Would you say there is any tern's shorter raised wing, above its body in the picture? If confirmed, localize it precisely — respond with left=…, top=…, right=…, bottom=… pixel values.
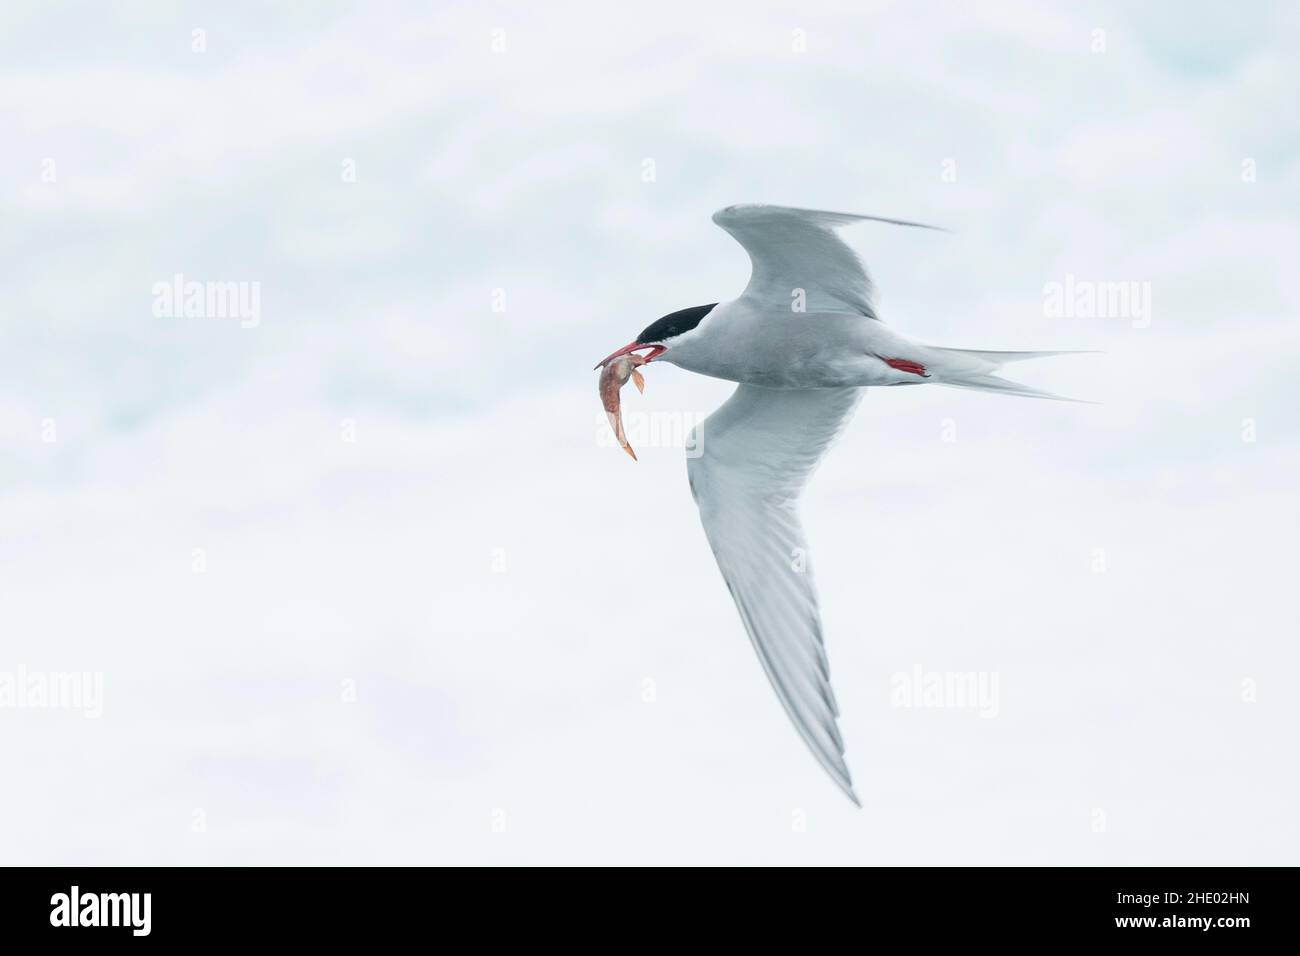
left=714, top=204, right=939, bottom=319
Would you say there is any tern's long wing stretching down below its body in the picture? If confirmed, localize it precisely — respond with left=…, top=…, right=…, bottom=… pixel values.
left=686, top=385, right=862, bottom=806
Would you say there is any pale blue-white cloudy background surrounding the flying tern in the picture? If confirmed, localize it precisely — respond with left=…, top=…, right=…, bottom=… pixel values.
left=0, top=3, right=1300, bottom=864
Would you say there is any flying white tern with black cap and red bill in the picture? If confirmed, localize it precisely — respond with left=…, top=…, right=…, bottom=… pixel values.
left=597, top=204, right=1067, bottom=806
